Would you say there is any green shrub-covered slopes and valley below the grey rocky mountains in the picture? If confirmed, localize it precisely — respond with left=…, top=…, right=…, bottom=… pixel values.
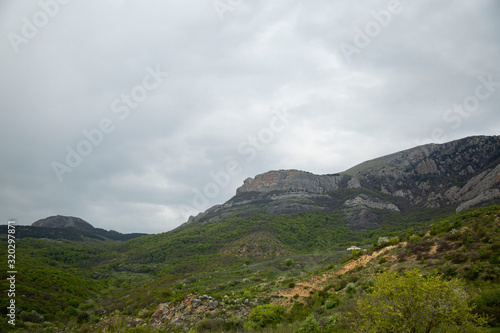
left=0, top=206, right=500, bottom=332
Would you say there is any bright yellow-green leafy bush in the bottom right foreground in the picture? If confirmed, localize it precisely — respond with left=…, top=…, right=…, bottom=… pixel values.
left=346, top=269, right=486, bottom=333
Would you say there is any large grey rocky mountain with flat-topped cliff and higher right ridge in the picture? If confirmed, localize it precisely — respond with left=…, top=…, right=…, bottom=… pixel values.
left=188, top=136, right=500, bottom=230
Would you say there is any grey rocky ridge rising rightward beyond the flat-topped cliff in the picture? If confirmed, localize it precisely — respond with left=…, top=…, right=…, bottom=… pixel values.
left=344, top=136, right=500, bottom=208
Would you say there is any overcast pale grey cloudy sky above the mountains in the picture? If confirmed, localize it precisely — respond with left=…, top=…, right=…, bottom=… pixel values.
left=0, top=0, right=500, bottom=233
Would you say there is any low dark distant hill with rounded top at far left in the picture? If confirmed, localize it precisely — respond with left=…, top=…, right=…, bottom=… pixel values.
left=0, top=215, right=146, bottom=241
